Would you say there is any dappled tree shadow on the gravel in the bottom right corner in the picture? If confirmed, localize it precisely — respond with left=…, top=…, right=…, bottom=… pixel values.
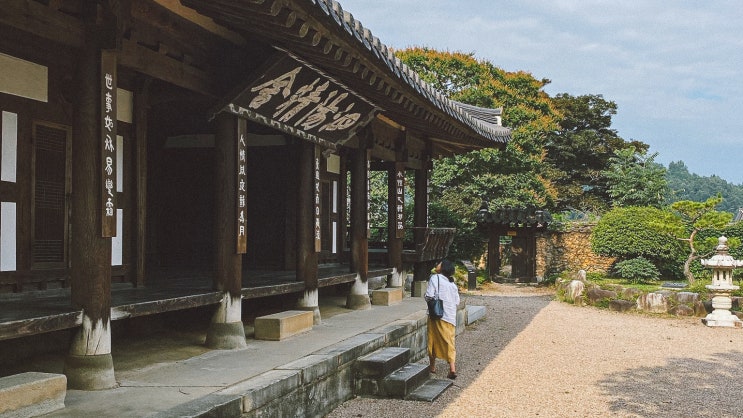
left=599, top=352, right=743, bottom=417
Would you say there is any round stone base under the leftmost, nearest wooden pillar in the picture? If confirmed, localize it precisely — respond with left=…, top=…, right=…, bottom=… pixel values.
left=64, top=353, right=118, bottom=390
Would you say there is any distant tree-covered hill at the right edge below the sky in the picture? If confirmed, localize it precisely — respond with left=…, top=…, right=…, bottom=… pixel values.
left=666, top=161, right=743, bottom=214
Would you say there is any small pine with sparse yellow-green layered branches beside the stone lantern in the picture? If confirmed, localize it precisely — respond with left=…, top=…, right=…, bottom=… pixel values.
left=659, top=196, right=732, bottom=284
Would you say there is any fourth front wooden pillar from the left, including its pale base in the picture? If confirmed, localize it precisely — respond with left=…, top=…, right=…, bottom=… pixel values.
left=346, top=137, right=371, bottom=309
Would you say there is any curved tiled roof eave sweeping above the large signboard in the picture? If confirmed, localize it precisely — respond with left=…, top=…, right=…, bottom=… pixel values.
left=182, top=0, right=511, bottom=151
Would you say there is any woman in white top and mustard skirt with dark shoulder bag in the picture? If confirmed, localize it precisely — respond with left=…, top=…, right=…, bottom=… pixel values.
left=425, top=259, right=459, bottom=379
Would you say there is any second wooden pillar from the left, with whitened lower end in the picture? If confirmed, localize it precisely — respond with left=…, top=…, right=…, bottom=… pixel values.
left=206, top=113, right=247, bottom=349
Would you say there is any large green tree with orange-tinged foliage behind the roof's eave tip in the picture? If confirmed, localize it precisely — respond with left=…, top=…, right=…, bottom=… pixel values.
left=396, top=48, right=558, bottom=258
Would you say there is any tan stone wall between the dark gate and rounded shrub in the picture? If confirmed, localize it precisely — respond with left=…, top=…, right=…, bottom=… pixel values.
left=536, top=223, right=615, bottom=278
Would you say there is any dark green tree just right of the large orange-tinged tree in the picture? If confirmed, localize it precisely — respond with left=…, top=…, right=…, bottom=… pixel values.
left=545, top=93, right=648, bottom=213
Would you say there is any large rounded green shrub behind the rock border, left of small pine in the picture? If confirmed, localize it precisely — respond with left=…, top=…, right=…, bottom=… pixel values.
left=591, top=206, right=684, bottom=278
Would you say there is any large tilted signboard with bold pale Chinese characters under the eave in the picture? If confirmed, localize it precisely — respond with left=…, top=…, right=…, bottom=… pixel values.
left=218, top=55, right=376, bottom=148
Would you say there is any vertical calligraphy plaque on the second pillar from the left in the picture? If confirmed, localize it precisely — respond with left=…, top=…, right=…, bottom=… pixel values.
left=235, top=118, right=248, bottom=254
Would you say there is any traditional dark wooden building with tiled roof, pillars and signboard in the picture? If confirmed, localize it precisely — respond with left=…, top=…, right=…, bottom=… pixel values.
left=0, top=0, right=510, bottom=389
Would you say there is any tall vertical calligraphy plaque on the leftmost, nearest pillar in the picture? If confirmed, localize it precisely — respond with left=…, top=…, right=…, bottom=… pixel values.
left=99, top=50, right=117, bottom=237
